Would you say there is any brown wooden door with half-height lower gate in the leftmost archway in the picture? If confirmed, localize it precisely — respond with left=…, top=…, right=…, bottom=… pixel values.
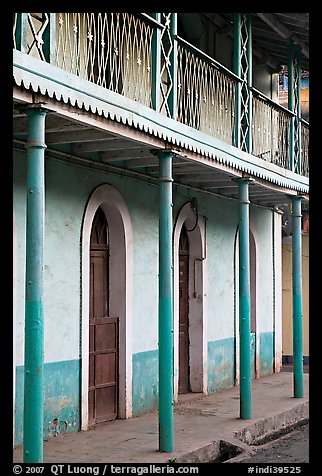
left=88, top=208, right=118, bottom=425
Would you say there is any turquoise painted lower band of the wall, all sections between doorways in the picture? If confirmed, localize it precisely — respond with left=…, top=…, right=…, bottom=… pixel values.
left=15, top=332, right=274, bottom=446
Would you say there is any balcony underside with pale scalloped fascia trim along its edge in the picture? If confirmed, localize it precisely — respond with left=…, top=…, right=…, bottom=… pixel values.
left=13, top=51, right=309, bottom=206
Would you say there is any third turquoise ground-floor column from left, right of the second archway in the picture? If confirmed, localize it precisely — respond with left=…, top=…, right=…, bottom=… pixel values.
left=237, top=179, right=252, bottom=420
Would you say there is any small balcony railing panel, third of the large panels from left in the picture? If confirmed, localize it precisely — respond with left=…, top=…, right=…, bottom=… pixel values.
left=252, top=88, right=292, bottom=169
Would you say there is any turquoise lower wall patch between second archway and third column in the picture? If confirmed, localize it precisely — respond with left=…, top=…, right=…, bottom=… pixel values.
left=208, top=337, right=235, bottom=393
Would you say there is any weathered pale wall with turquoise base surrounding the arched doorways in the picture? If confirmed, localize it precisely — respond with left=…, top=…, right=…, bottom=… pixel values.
left=14, top=146, right=280, bottom=441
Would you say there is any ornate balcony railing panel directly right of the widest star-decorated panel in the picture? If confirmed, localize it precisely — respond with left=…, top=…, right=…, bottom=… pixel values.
left=176, top=38, right=237, bottom=144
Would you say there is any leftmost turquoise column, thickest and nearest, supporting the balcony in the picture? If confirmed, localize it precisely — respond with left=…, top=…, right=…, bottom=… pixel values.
left=23, top=106, right=46, bottom=463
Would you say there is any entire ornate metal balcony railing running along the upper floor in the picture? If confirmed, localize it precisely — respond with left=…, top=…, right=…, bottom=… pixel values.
left=13, top=13, right=309, bottom=176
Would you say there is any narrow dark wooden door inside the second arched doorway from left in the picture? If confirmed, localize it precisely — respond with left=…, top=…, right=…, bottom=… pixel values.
left=179, top=227, right=190, bottom=393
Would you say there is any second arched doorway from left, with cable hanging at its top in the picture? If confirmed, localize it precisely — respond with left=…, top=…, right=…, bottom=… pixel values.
left=173, top=201, right=208, bottom=401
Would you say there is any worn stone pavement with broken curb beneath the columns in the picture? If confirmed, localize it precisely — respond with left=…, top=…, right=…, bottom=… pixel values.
left=13, top=372, right=309, bottom=463
